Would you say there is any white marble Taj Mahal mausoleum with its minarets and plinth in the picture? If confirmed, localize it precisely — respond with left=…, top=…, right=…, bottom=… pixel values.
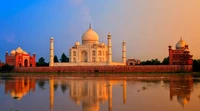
left=49, top=24, right=126, bottom=66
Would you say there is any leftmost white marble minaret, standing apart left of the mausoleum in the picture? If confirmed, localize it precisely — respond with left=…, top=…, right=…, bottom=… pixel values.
left=49, top=37, right=54, bottom=66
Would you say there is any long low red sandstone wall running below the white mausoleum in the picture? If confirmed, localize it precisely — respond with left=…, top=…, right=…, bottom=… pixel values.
left=13, top=65, right=192, bottom=73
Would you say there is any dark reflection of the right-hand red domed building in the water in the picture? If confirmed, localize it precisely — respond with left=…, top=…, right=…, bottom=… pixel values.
left=170, top=75, right=193, bottom=107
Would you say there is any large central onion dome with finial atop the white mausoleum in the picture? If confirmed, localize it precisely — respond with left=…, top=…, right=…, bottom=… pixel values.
left=82, top=25, right=99, bottom=45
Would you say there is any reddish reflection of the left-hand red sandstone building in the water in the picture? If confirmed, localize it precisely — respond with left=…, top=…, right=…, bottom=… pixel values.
left=5, top=77, right=35, bottom=100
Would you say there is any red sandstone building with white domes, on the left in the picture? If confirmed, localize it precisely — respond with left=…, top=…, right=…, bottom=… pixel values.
left=5, top=47, right=36, bottom=67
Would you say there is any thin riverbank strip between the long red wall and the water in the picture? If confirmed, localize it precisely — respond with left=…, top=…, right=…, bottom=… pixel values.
left=0, top=73, right=200, bottom=80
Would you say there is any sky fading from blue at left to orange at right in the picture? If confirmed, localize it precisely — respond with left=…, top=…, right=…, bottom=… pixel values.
left=0, top=0, right=200, bottom=62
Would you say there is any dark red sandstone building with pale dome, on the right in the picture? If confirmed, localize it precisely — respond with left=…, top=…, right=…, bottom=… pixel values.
left=169, top=38, right=193, bottom=65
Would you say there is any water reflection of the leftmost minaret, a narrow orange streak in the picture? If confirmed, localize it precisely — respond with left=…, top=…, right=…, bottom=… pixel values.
left=49, top=77, right=54, bottom=110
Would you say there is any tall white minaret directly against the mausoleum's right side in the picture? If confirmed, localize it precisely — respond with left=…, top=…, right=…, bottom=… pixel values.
left=108, top=33, right=112, bottom=65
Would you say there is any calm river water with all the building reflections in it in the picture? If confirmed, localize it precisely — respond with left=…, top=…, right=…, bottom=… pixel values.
left=0, top=75, right=200, bottom=111
